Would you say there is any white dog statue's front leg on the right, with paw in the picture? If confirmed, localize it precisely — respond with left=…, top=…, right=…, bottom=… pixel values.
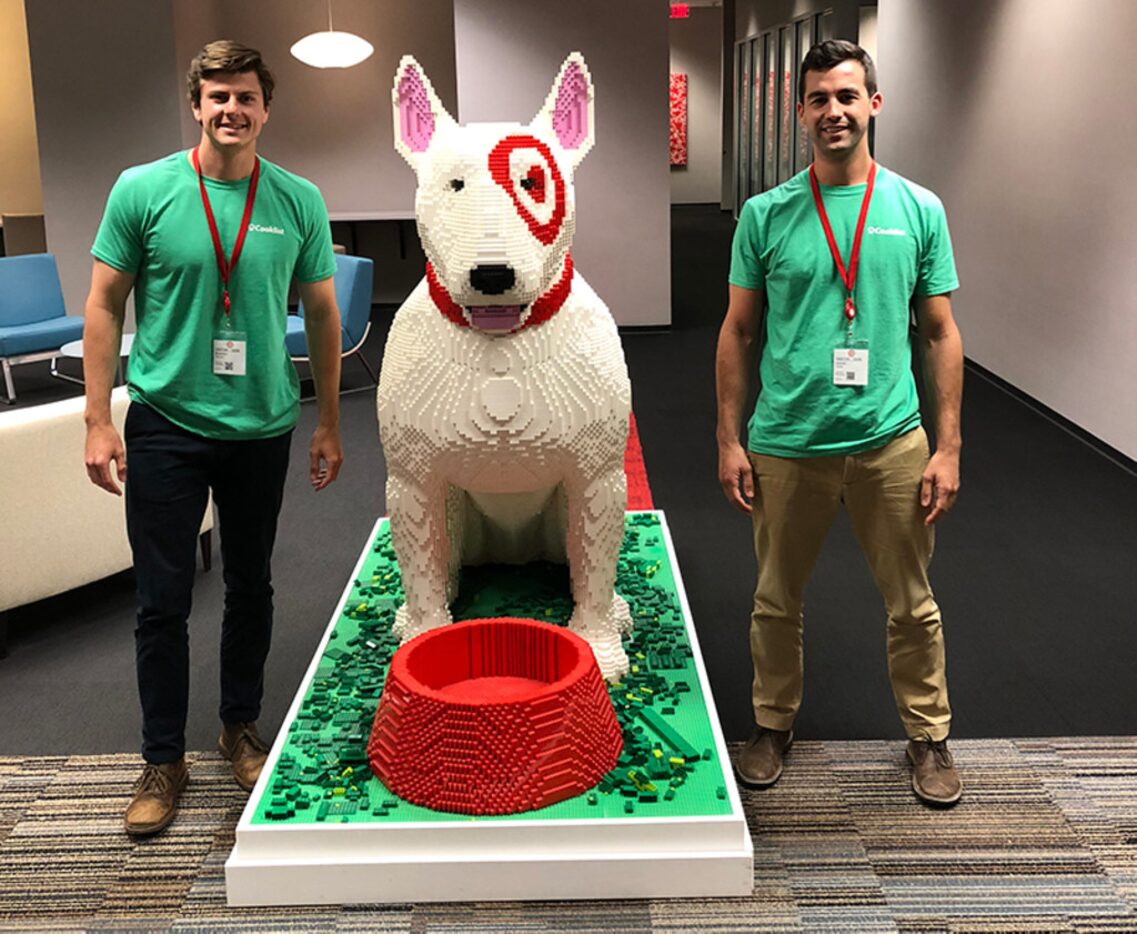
left=565, top=464, right=631, bottom=681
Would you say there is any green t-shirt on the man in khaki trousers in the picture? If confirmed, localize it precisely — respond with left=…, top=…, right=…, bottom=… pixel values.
left=730, top=167, right=960, bottom=457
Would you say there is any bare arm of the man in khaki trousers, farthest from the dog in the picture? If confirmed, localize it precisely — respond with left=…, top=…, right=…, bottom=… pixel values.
left=914, top=294, right=963, bottom=526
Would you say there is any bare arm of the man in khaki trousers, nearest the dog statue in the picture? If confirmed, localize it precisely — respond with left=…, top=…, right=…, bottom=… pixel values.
left=715, top=286, right=766, bottom=513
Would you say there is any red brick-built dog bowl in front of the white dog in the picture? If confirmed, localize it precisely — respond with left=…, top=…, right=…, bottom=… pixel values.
left=367, top=618, right=623, bottom=815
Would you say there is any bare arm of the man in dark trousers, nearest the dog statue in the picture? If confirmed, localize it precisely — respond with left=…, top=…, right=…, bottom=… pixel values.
left=299, top=276, right=343, bottom=489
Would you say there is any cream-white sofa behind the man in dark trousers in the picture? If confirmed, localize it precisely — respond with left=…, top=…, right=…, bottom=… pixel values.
left=0, top=387, right=213, bottom=656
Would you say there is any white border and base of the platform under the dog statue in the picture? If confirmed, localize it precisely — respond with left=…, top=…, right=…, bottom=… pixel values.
left=225, top=513, right=754, bottom=906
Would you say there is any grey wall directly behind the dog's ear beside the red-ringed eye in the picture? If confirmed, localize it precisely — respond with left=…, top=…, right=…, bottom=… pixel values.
left=454, top=0, right=671, bottom=325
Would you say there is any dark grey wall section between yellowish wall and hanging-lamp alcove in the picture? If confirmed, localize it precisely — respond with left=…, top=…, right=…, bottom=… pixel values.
left=27, top=0, right=181, bottom=314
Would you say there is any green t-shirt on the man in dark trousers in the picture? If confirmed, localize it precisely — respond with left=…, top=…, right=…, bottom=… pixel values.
left=91, top=151, right=335, bottom=439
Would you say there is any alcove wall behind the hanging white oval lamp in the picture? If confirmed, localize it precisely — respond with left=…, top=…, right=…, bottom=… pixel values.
left=167, top=0, right=456, bottom=216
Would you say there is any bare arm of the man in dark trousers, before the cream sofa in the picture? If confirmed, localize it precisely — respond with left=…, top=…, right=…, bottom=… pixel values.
left=83, top=259, right=134, bottom=496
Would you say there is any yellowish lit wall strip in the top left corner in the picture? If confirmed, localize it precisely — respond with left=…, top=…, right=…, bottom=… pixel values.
left=0, top=0, right=43, bottom=214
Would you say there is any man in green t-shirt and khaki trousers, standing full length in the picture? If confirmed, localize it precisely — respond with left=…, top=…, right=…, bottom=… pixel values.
left=715, top=40, right=963, bottom=804
